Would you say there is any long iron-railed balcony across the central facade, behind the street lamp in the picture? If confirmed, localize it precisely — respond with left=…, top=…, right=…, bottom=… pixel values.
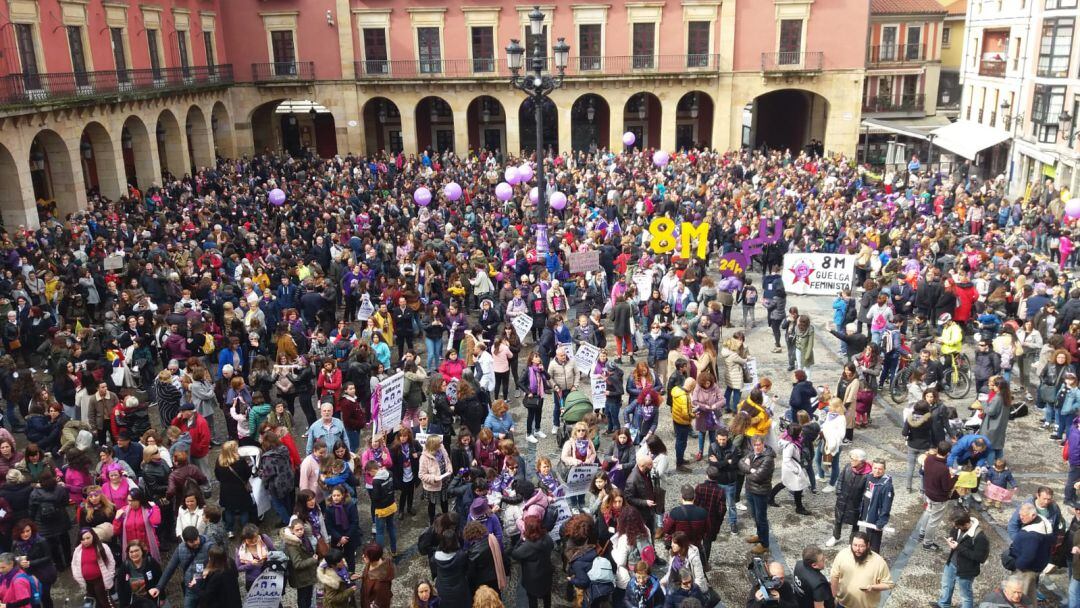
left=355, top=54, right=720, bottom=81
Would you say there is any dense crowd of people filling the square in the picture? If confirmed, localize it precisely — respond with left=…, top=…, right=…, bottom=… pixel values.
left=0, top=140, right=1080, bottom=608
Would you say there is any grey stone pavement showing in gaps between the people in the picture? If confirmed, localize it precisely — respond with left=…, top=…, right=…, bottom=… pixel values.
left=44, top=296, right=1068, bottom=608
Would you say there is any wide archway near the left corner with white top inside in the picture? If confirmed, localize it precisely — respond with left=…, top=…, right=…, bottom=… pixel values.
left=252, top=99, right=337, bottom=159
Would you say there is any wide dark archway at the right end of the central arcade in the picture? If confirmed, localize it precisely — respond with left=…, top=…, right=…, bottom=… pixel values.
left=743, top=89, right=828, bottom=154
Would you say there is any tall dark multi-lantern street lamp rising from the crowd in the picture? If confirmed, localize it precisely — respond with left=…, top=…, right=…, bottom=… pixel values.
left=507, top=6, right=570, bottom=222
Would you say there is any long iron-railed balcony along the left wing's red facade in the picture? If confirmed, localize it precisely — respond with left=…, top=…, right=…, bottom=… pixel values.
left=0, top=64, right=233, bottom=106
